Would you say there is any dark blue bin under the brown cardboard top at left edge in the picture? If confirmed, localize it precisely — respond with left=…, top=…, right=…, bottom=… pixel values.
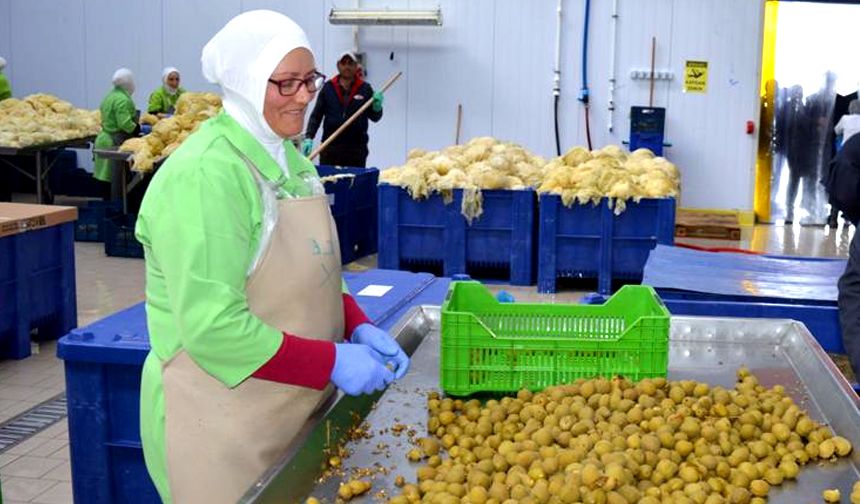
left=0, top=222, right=78, bottom=359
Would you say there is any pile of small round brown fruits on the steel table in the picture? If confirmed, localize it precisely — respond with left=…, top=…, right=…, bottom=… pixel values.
left=389, top=368, right=858, bottom=504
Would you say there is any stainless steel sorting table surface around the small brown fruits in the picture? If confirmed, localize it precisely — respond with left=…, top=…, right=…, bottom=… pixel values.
left=240, top=306, right=860, bottom=503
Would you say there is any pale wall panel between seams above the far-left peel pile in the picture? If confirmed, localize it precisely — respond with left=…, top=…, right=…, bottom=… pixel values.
left=6, top=0, right=87, bottom=106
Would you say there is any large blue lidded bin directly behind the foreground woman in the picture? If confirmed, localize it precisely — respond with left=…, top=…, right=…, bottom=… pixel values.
left=57, top=270, right=448, bottom=504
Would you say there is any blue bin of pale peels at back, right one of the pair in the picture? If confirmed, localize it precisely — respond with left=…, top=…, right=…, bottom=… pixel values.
left=538, top=195, right=675, bottom=294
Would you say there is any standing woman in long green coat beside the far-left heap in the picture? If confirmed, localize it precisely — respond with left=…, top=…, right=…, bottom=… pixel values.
left=93, top=68, right=140, bottom=200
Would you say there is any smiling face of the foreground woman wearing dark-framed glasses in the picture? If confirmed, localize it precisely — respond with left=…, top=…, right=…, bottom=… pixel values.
left=263, top=48, right=316, bottom=138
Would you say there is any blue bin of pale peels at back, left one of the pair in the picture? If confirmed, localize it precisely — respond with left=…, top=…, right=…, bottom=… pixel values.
left=378, top=184, right=536, bottom=285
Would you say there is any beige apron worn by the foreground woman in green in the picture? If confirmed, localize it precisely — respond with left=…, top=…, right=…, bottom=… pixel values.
left=162, top=152, right=344, bottom=504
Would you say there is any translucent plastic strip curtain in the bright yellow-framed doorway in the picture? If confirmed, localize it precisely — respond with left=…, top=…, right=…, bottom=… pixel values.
left=756, top=1, right=848, bottom=225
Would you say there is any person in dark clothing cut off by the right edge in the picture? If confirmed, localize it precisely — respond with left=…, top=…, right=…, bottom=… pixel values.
left=825, top=135, right=860, bottom=376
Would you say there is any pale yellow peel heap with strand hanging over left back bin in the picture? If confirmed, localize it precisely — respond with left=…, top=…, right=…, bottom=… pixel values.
left=379, top=137, right=546, bottom=220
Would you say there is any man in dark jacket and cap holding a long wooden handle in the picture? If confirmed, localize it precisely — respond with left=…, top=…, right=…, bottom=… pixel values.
left=302, top=52, right=382, bottom=168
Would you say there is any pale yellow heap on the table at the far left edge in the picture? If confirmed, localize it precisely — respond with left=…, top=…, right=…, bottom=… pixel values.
left=0, top=94, right=101, bottom=148
